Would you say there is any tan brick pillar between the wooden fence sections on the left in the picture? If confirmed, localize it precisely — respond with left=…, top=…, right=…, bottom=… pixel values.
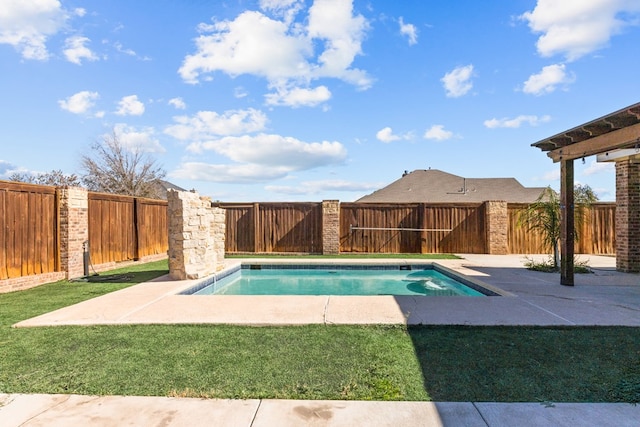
left=58, top=187, right=89, bottom=279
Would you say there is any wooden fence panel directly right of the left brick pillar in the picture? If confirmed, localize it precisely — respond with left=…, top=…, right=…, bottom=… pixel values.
left=88, top=192, right=138, bottom=265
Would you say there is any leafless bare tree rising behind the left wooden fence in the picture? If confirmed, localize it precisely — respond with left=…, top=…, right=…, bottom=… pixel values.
left=81, top=132, right=166, bottom=198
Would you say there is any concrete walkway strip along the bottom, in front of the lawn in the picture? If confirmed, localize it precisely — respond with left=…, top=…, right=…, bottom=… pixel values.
left=0, top=394, right=640, bottom=427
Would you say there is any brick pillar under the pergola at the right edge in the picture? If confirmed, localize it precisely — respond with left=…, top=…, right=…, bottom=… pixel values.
left=616, top=159, right=640, bottom=273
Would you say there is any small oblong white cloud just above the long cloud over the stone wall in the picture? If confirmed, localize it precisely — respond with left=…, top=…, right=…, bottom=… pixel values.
left=164, top=108, right=267, bottom=141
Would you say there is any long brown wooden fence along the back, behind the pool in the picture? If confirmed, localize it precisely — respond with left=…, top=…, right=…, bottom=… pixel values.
left=220, top=203, right=615, bottom=255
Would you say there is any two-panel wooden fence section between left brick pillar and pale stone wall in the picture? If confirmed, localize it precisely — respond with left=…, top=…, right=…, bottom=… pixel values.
left=88, top=192, right=169, bottom=265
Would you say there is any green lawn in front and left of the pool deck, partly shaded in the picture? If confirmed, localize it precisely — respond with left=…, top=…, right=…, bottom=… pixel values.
left=0, top=261, right=640, bottom=402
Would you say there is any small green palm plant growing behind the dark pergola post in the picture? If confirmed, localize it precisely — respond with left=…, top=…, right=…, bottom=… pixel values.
left=518, top=185, right=598, bottom=270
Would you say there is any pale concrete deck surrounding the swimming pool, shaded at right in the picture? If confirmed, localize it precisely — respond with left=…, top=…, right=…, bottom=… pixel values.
left=15, top=254, right=640, bottom=327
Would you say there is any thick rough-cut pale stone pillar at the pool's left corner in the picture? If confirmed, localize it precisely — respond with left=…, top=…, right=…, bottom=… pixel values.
left=167, top=190, right=224, bottom=280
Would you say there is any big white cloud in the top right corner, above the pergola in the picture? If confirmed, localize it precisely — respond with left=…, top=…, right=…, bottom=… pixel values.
left=521, top=0, right=640, bottom=61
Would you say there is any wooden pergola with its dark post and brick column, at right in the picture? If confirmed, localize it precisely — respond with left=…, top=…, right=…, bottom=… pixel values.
left=531, top=103, right=640, bottom=286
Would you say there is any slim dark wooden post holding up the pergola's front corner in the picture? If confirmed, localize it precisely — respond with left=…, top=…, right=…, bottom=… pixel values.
left=560, top=160, right=575, bottom=286
